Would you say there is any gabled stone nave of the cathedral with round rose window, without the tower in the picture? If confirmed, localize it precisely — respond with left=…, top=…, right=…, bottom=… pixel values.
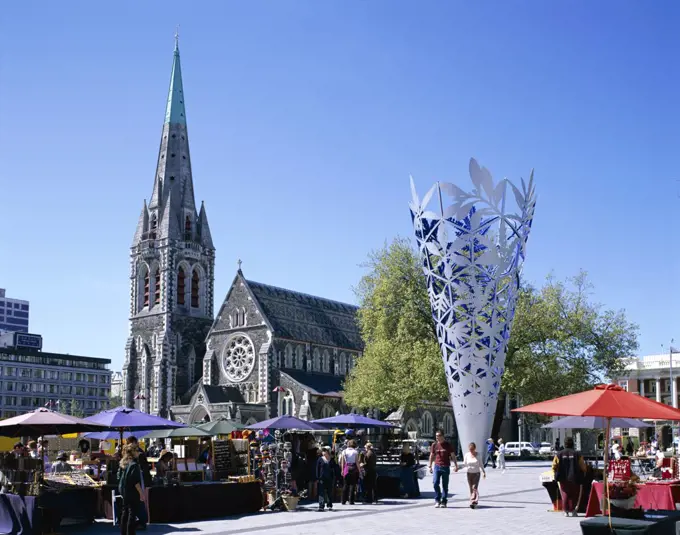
left=172, top=269, right=455, bottom=438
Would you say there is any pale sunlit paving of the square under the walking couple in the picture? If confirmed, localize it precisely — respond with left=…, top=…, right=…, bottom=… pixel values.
left=88, top=462, right=582, bottom=535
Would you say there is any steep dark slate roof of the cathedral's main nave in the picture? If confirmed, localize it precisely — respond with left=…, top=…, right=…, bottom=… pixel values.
left=247, top=280, right=363, bottom=351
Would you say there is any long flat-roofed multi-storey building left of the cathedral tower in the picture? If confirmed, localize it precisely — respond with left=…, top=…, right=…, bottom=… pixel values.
left=0, top=347, right=111, bottom=418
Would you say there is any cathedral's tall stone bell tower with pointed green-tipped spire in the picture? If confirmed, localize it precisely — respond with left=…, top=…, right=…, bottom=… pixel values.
left=122, top=39, right=215, bottom=416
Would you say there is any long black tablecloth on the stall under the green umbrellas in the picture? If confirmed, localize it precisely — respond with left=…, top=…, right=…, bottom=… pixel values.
left=146, top=482, right=263, bottom=524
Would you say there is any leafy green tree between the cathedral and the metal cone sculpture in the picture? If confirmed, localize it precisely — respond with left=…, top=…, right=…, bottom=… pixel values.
left=345, top=238, right=448, bottom=410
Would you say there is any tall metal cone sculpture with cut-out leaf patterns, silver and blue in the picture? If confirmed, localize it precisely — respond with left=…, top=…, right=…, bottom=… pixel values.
left=410, top=159, right=536, bottom=451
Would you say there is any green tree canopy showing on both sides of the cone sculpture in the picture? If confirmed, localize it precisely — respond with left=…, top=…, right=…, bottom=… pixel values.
left=345, top=238, right=638, bottom=410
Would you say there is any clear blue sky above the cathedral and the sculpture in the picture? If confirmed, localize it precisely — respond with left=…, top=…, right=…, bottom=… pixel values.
left=0, top=0, right=680, bottom=368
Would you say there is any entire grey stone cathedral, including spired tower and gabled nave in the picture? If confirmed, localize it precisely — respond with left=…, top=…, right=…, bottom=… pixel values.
left=123, top=42, right=455, bottom=437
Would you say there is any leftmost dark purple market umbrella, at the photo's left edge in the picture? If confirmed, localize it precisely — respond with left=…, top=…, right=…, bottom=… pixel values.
left=0, top=408, right=106, bottom=437
